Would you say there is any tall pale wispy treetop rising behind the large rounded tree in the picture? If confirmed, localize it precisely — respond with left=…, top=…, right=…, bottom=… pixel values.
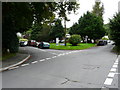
left=92, top=0, right=104, bottom=17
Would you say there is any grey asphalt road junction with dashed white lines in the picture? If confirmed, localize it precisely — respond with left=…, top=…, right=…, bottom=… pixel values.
left=2, top=44, right=119, bottom=88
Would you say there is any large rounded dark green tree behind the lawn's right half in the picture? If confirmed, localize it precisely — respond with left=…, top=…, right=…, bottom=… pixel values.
left=76, top=12, right=105, bottom=41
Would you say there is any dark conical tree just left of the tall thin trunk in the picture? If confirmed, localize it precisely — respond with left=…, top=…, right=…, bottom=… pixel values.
left=49, top=19, right=65, bottom=40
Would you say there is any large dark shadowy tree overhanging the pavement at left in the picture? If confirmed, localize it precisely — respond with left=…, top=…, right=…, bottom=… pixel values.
left=2, top=2, right=56, bottom=53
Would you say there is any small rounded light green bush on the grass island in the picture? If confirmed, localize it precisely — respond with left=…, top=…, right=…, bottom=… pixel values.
left=69, top=35, right=81, bottom=46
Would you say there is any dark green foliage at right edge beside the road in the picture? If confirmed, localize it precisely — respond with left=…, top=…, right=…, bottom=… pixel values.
left=110, top=13, right=120, bottom=47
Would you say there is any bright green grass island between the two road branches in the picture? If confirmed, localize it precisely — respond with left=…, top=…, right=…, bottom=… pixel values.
left=50, top=43, right=96, bottom=50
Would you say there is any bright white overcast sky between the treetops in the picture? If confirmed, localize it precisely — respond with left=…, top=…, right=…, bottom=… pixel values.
left=62, top=0, right=120, bottom=28
